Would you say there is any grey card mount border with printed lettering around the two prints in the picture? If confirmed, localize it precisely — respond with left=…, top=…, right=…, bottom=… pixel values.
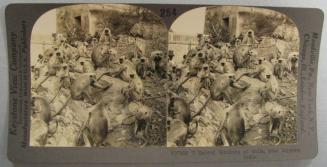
left=6, top=3, right=324, bottom=163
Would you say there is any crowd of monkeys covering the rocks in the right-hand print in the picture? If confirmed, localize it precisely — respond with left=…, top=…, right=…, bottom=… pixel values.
left=167, top=30, right=299, bottom=146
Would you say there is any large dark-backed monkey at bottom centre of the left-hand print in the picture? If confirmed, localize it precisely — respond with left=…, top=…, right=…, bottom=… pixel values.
left=85, top=101, right=109, bottom=147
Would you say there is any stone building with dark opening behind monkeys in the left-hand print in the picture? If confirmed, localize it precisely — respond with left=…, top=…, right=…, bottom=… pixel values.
left=56, top=4, right=167, bottom=54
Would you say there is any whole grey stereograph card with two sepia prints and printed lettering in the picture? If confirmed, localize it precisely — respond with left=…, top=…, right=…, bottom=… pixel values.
left=6, top=4, right=323, bottom=166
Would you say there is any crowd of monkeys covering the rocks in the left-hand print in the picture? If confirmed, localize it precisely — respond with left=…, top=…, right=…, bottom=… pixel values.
left=31, top=28, right=169, bottom=146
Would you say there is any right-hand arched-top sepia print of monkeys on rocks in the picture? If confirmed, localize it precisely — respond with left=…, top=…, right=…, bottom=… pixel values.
left=165, top=6, right=300, bottom=147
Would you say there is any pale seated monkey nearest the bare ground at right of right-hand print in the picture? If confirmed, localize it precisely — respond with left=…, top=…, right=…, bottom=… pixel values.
left=259, top=74, right=279, bottom=102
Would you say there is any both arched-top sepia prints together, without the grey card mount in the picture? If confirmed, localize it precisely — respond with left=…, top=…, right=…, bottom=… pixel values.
left=29, top=4, right=300, bottom=148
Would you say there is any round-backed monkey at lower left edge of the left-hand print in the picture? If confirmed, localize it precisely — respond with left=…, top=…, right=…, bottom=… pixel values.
left=31, top=96, right=51, bottom=125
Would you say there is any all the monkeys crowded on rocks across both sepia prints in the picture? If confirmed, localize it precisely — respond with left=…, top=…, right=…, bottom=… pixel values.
left=31, top=28, right=298, bottom=146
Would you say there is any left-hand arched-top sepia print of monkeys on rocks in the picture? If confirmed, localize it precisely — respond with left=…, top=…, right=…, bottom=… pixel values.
left=29, top=4, right=169, bottom=148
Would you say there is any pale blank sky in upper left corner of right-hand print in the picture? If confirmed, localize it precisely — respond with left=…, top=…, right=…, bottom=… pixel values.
left=171, top=7, right=206, bottom=35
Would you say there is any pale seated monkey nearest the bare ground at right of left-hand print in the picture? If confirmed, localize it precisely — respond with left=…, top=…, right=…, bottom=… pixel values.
left=122, top=74, right=144, bottom=102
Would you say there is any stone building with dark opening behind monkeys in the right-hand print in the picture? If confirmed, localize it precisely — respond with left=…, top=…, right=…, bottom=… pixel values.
left=205, top=6, right=295, bottom=37
